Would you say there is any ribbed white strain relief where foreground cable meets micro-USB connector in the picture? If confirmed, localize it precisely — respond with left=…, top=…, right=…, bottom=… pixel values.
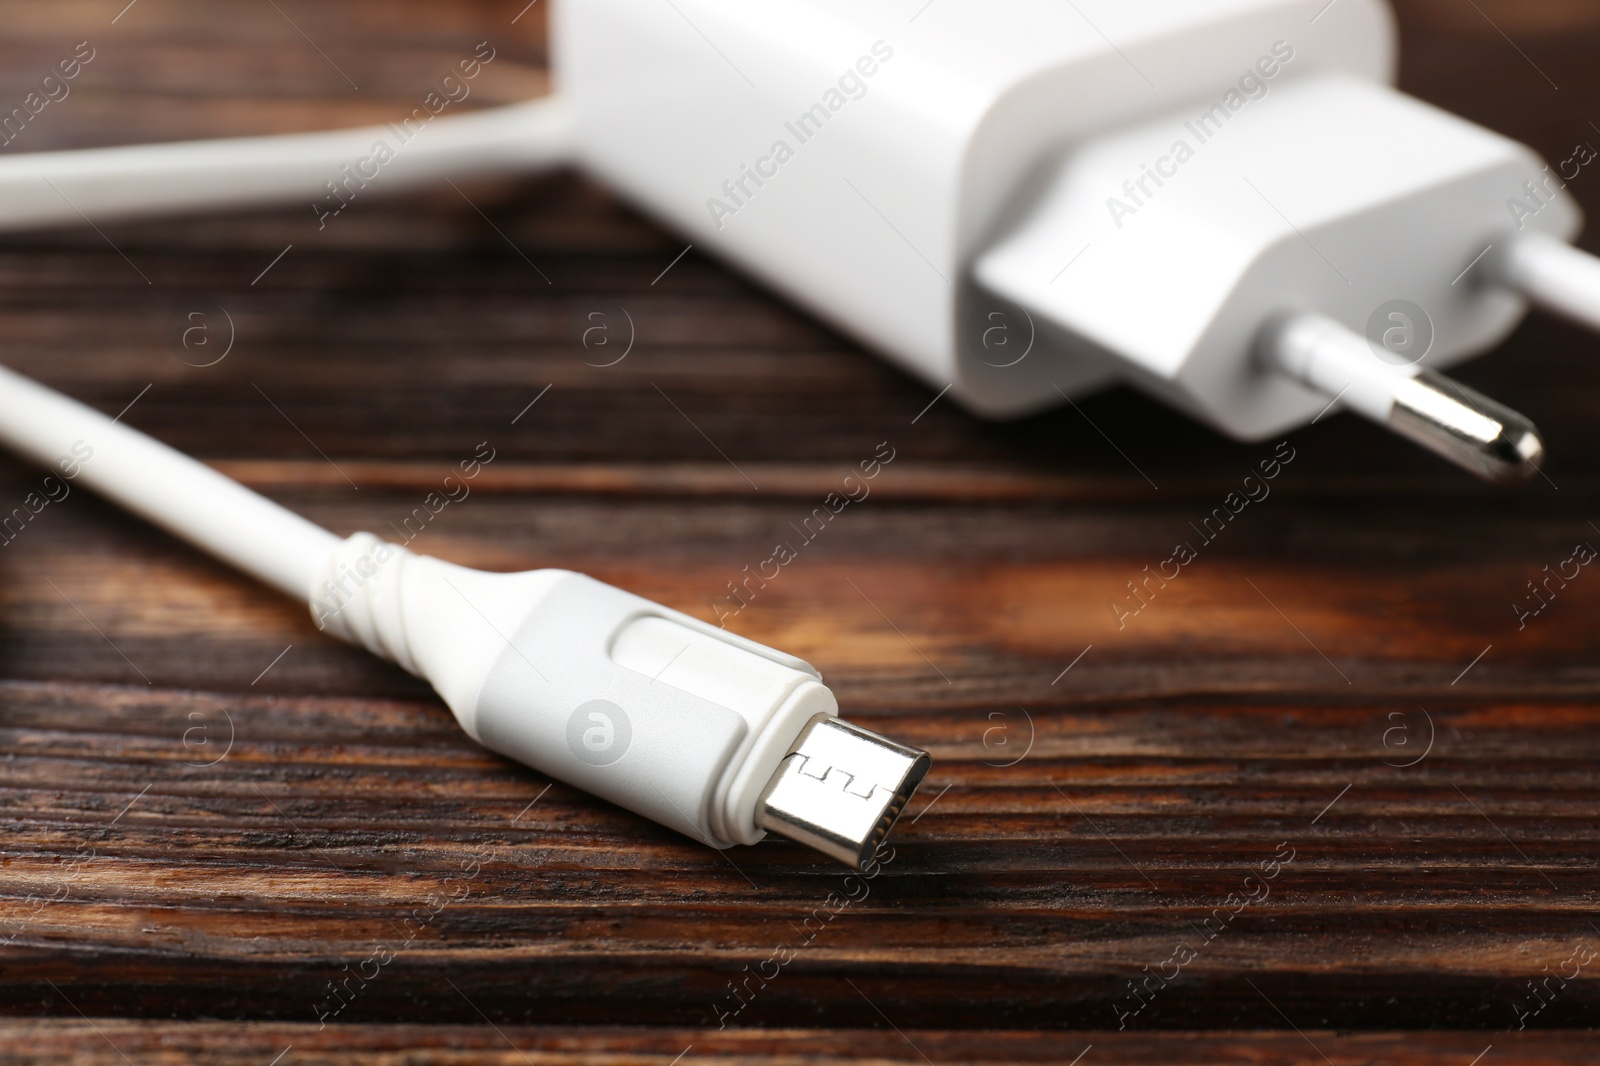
left=307, top=533, right=422, bottom=677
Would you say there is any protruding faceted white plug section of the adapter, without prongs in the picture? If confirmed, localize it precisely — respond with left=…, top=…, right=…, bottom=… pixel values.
left=974, top=74, right=1581, bottom=440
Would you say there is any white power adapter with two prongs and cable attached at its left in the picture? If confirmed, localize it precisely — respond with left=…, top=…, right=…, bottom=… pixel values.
left=0, top=0, right=1600, bottom=480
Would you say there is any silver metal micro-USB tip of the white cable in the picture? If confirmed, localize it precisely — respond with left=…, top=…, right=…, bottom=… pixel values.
left=755, top=714, right=930, bottom=869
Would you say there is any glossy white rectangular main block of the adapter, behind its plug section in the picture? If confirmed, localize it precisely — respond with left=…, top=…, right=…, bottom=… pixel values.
left=552, top=0, right=1395, bottom=416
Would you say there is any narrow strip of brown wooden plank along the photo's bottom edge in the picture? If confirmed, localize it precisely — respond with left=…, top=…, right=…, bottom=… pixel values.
left=0, top=1021, right=1594, bottom=1066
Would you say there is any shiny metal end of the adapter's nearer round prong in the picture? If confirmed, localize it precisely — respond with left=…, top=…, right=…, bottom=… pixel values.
left=1389, top=370, right=1544, bottom=483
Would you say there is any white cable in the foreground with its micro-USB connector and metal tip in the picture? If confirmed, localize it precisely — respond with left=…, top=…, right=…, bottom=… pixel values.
left=0, top=368, right=928, bottom=868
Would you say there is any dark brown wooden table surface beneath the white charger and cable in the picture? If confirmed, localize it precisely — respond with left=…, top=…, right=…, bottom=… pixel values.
left=0, top=0, right=1600, bottom=1066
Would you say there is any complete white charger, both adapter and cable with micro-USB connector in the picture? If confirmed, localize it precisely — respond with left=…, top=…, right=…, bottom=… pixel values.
left=0, top=0, right=1600, bottom=866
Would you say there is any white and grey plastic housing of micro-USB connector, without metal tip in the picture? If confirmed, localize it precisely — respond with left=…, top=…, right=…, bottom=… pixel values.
left=310, top=533, right=838, bottom=847
